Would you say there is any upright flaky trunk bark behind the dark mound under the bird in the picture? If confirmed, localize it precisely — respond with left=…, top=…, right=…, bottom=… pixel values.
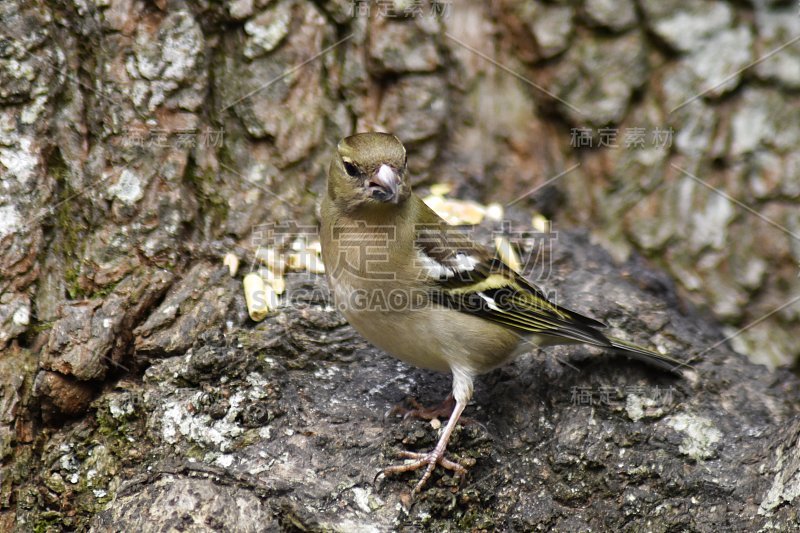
left=0, top=0, right=800, bottom=524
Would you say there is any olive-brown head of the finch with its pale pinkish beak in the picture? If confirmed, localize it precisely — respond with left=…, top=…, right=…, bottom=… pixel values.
left=328, top=132, right=411, bottom=210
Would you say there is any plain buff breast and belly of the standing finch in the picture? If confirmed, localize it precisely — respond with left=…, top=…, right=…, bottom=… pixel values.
left=322, top=215, right=521, bottom=374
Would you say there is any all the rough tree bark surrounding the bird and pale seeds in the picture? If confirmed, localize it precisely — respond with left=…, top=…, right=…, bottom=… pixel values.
left=0, top=0, right=800, bottom=531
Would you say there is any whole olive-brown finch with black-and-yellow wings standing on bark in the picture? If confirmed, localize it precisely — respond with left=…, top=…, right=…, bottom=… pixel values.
left=320, top=132, right=686, bottom=495
